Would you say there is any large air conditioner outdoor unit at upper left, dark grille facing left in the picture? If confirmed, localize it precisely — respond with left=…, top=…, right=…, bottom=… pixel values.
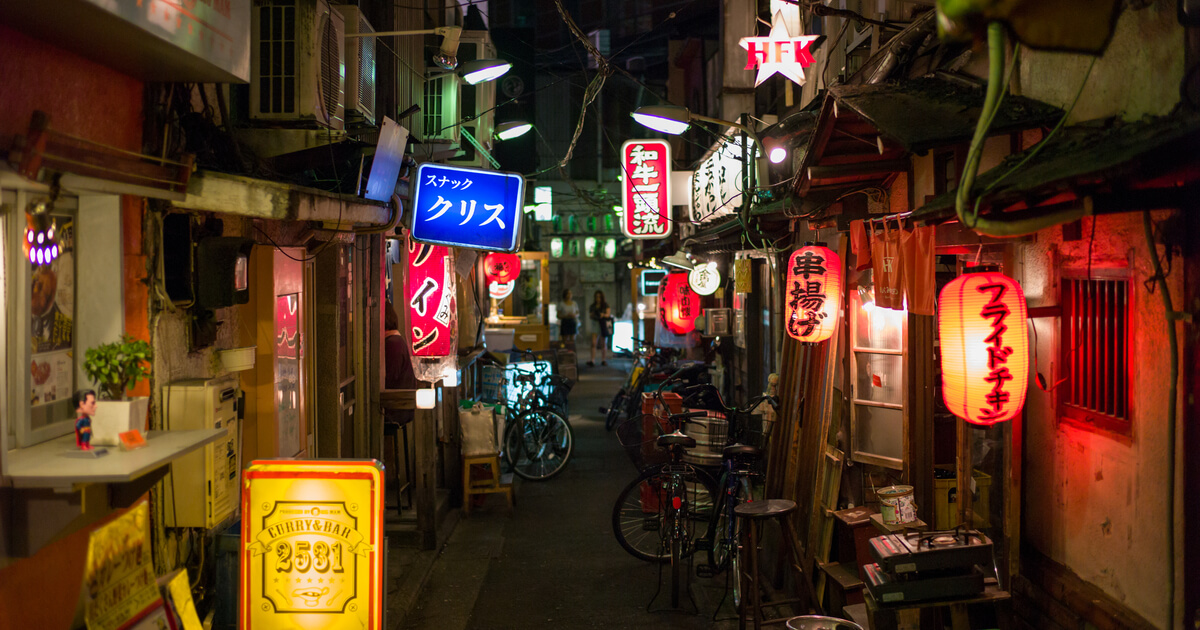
left=250, top=0, right=346, bottom=131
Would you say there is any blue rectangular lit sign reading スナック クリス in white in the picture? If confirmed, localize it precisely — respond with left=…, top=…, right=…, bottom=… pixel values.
left=413, top=162, right=524, bottom=252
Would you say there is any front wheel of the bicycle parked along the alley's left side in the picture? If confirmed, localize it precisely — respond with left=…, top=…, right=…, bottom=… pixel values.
left=504, top=408, right=575, bottom=481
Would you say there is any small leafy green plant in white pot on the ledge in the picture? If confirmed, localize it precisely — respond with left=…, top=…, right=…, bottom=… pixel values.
left=83, top=335, right=154, bottom=446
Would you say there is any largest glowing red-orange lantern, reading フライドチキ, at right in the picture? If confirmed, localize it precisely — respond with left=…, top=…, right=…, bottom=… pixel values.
left=937, top=272, right=1030, bottom=426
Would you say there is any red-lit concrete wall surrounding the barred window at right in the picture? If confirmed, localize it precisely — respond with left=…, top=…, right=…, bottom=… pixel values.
left=1016, top=212, right=1183, bottom=626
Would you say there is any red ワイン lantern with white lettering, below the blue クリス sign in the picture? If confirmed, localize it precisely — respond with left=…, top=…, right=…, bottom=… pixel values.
left=406, top=240, right=458, bottom=355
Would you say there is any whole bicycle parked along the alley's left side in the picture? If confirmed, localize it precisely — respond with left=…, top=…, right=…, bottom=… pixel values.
left=475, top=350, right=575, bottom=481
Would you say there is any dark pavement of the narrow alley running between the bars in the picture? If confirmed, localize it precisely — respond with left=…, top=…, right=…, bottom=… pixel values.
left=398, top=361, right=737, bottom=630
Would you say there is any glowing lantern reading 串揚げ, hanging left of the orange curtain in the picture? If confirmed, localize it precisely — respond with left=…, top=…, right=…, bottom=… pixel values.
left=784, top=245, right=841, bottom=342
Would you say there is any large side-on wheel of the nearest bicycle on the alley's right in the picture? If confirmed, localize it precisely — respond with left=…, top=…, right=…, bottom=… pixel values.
left=612, top=463, right=716, bottom=562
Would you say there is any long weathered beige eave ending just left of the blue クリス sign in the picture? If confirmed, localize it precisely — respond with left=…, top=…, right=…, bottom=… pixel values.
left=174, top=170, right=391, bottom=226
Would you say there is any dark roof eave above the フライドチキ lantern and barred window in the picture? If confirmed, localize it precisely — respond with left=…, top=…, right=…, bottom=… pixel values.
left=912, top=114, right=1200, bottom=223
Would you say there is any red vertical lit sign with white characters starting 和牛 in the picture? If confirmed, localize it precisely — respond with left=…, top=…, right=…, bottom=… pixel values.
left=620, top=140, right=672, bottom=239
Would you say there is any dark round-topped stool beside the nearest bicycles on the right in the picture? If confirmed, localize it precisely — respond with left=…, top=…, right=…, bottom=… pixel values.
left=733, top=499, right=811, bottom=630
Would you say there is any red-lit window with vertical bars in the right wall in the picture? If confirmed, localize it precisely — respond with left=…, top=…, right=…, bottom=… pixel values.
left=1057, top=269, right=1132, bottom=437
